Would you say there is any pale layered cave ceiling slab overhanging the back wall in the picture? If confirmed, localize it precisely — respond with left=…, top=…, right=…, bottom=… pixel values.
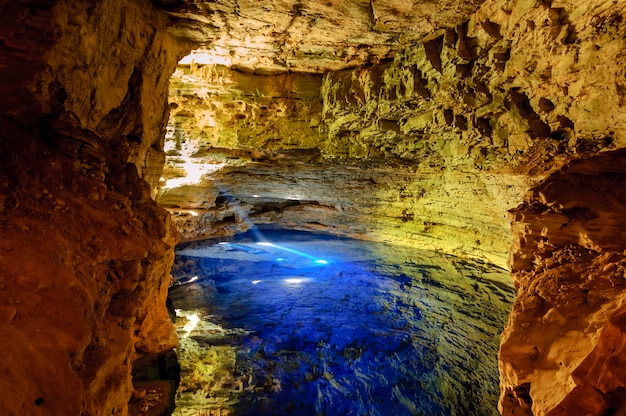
left=154, top=0, right=482, bottom=73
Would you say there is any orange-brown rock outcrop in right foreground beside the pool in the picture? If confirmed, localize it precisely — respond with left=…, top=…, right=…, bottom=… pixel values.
left=500, top=149, right=626, bottom=415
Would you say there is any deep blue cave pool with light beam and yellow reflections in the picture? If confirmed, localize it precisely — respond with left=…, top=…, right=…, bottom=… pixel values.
left=170, top=232, right=514, bottom=416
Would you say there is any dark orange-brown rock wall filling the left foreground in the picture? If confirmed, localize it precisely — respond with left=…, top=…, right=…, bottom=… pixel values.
left=0, top=0, right=181, bottom=415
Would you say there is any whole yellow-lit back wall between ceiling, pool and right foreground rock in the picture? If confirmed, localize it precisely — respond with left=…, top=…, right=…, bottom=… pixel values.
left=160, top=2, right=625, bottom=266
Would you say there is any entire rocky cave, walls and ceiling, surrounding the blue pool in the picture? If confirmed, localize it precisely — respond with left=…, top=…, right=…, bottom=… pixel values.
left=0, top=0, right=626, bottom=416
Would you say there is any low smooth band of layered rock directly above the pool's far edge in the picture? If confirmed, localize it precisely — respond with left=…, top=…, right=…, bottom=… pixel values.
left=159, top=152, right=528, bottom=267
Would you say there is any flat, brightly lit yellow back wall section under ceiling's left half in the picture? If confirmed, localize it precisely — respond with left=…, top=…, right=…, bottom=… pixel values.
left=168, top=63, right=322, bottom=153
